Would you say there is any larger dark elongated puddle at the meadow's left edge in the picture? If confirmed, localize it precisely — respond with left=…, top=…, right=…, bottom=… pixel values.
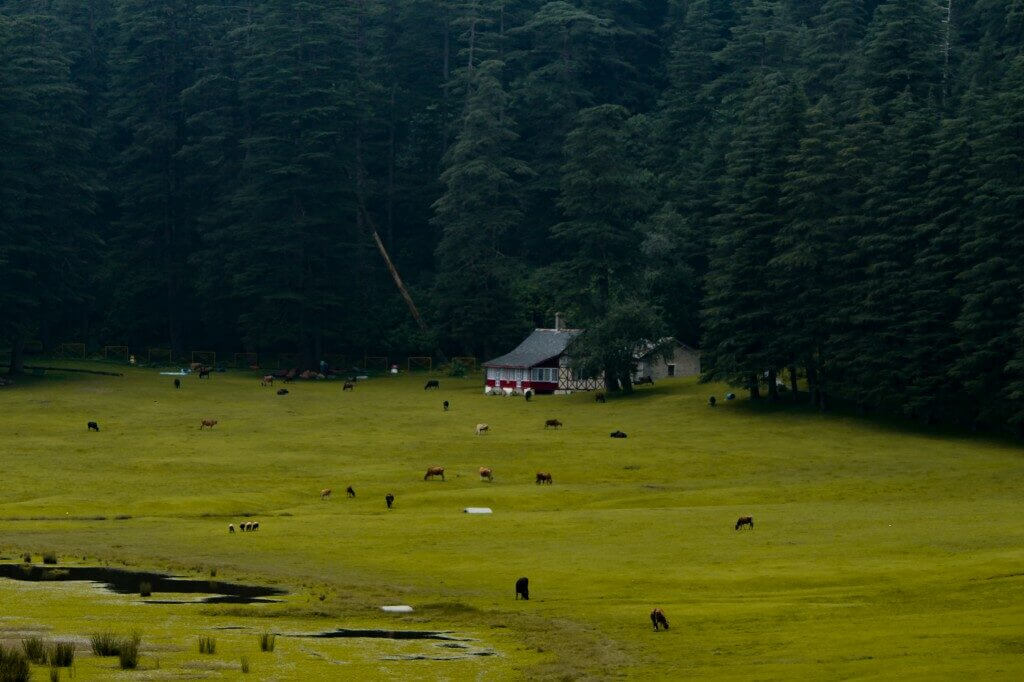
left=0, top=563, right=286, bottom=604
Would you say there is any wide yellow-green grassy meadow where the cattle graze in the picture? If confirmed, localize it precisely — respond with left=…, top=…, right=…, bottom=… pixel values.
left=0, top=364, right=1024, bottom=680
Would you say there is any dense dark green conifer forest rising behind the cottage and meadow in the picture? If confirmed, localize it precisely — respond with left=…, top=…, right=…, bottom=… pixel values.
left=0, top=0, right=1024, bottom=431
